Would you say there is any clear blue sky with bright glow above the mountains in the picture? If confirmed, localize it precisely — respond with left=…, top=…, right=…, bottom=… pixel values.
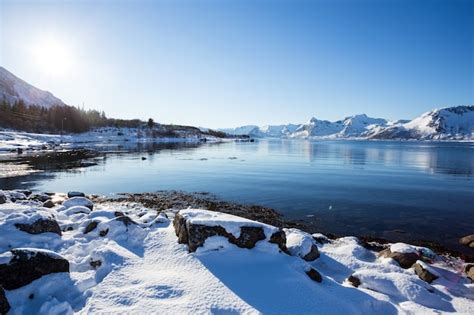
left=0, top=0, right=474, bottom=128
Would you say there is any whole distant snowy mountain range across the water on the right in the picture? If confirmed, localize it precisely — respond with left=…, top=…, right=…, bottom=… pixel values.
left=221, top=105, right=474, bottom=140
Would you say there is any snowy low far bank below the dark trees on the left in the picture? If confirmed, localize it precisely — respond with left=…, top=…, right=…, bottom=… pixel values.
left=0, top=127, right=222, bottom=153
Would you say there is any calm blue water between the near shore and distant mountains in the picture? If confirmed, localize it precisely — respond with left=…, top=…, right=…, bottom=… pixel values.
left=0, top=140, right=474, bottom=254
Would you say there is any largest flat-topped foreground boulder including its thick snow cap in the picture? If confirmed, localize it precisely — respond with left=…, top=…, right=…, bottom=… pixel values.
left=173, top=209, right=287, bottom=252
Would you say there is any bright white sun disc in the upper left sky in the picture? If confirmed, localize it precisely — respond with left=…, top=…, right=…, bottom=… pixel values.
left=33, top=38, right=73, bottom=76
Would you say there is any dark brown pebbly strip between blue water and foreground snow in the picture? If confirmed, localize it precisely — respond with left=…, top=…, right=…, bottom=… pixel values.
left=96, top=190, right=474, bottom=263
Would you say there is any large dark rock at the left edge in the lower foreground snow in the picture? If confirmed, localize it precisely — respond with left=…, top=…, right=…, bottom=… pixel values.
left=0, top=248, right=69, bottom=290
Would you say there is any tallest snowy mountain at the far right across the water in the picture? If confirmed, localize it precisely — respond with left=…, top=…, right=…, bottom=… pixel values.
left=368, top=105, right=474, bottom=140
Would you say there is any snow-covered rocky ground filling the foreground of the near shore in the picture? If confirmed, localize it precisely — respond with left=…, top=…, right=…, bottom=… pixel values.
left=0, top=191, right=474, bottom=314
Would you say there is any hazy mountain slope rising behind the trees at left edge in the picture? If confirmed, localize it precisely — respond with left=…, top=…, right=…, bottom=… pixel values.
left=0, top=67, right=64, bottom=107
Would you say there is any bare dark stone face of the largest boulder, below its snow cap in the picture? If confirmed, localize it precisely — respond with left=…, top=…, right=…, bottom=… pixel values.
left=173, top=213, right=286, bottom=252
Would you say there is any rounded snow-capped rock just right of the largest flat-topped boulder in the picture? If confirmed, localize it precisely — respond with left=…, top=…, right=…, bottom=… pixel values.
left=283, top=229, right=319, bottom=261
